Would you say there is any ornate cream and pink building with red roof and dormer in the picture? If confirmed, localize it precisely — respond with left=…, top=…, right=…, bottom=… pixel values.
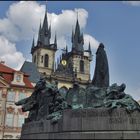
left=0, top=63, right=33, bottom=139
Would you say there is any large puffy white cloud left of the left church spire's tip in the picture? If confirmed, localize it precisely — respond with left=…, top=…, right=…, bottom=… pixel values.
left=0, top=1, right=45, bottom=41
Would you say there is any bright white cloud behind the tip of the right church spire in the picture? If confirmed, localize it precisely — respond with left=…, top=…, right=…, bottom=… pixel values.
left=49, top=9, right=88, bottom=37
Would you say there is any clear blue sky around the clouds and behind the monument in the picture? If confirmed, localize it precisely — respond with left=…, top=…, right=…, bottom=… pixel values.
left=0, top=1, right=140, bottom=100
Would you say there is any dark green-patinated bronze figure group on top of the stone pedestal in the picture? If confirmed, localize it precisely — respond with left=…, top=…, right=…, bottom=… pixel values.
left=15, top=43, right=140, bottom=123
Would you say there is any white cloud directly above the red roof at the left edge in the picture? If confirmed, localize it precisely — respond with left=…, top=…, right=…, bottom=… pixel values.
left=0, top=36, right=25, bottom=69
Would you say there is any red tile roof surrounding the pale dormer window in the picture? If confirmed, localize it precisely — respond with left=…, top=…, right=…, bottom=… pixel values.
left=0, top=63, right=33, bottom=88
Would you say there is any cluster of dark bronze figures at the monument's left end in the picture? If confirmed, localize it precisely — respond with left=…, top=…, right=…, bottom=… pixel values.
left=15, top=77, right=71, bottom=122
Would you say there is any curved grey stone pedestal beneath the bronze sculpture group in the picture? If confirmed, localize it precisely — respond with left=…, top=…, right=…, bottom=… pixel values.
left=21, top=109, right=140, bottom=139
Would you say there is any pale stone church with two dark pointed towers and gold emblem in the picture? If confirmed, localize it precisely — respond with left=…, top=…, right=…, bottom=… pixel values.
left=31, top=6, right=92, bottom=88
